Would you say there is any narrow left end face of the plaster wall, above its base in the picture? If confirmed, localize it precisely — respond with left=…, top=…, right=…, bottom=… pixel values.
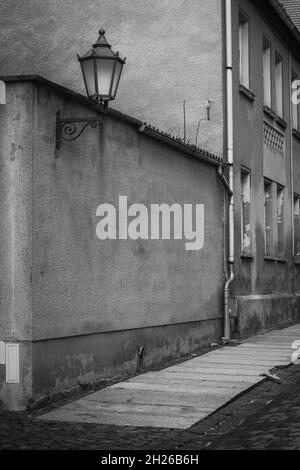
left=0, top=83, right=32, bottom=340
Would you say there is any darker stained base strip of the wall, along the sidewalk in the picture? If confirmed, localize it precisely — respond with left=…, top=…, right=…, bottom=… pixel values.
left=32, top=318, right=222, bottom=400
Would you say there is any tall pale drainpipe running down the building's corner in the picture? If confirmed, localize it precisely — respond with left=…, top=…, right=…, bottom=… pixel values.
left=223, top=0, right=234, bottom=343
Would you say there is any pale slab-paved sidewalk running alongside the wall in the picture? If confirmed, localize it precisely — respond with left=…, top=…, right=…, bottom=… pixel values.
left=38, top=325, right=300, bottom=429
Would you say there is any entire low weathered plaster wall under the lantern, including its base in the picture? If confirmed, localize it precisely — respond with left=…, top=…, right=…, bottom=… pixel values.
left=0, top=81, right=224, bottom=409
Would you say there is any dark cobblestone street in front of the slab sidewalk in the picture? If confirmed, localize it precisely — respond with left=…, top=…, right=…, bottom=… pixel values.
left=0, top=366, right=300, bottom=450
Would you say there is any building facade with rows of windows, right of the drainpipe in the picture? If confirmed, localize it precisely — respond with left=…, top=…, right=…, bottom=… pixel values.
left=232, top=1, right=300, bottom=335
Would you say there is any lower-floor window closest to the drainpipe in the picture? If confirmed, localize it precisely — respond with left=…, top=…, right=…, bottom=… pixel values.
left=241, top=170, right=251, bottom=254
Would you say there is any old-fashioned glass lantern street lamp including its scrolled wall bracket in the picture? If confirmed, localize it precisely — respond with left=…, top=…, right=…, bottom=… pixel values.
left=56, top=28, right=126, bottom=149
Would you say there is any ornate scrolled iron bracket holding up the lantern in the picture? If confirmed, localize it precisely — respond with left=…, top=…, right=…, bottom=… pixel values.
left=56, top=111, right=103, bottom=149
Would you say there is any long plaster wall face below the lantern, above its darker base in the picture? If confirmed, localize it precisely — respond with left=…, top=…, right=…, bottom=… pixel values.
left=32, top=80, right=223, bottom=340
